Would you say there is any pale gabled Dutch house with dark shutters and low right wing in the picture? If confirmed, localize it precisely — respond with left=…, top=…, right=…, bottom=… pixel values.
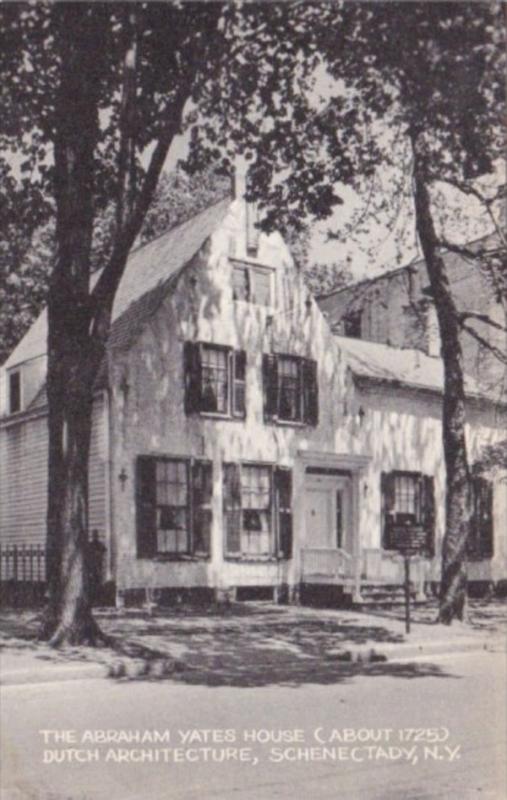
left=0, top=199, right=507, bottom=603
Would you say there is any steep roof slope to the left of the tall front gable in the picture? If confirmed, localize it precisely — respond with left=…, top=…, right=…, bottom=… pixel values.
left=3, top=198, right=230, bottom=368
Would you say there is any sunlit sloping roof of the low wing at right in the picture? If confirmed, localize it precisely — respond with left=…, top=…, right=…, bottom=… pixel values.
left=335, top=336, right=495, bottom=402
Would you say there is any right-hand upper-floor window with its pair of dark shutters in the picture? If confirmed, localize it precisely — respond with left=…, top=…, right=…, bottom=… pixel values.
left=262, top=354, right=319, bottom=425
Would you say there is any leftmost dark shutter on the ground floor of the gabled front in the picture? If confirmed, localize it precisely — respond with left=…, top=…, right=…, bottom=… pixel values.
left=136, top=456, right=157, bottom=558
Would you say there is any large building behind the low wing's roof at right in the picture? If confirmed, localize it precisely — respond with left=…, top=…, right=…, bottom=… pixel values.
left=318, top=234, right=507, bottom=399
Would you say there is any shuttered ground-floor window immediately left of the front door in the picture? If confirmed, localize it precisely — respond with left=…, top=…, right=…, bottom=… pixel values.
left=223, top=464, right=292, bottom=559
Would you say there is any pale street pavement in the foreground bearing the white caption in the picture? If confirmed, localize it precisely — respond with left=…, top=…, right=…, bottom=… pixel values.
left=1, top=651, right=507, bottom=800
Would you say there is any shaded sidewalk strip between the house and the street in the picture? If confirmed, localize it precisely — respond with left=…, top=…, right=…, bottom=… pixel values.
left=0, top=601, right=507, bottom=686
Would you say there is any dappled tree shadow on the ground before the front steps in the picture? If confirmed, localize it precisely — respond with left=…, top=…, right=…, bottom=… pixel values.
left=104, top=620, right=460, bottom=687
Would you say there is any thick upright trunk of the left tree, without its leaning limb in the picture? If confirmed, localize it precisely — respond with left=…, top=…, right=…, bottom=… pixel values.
left=42, top=3, right=108, bottom=645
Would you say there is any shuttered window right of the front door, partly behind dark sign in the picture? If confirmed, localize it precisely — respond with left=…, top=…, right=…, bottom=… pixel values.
left=380, top=472, right=435, bottom=557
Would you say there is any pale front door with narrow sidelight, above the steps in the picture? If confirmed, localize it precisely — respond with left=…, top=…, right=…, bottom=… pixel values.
left=305, top=475, right=352, bottom=553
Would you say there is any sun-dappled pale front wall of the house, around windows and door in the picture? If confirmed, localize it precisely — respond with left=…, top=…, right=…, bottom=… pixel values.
left=110, top=201, right=507, bottom=590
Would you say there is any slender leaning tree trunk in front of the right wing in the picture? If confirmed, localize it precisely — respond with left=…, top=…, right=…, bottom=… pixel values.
left=414, top=150, right=470, bottom=624
